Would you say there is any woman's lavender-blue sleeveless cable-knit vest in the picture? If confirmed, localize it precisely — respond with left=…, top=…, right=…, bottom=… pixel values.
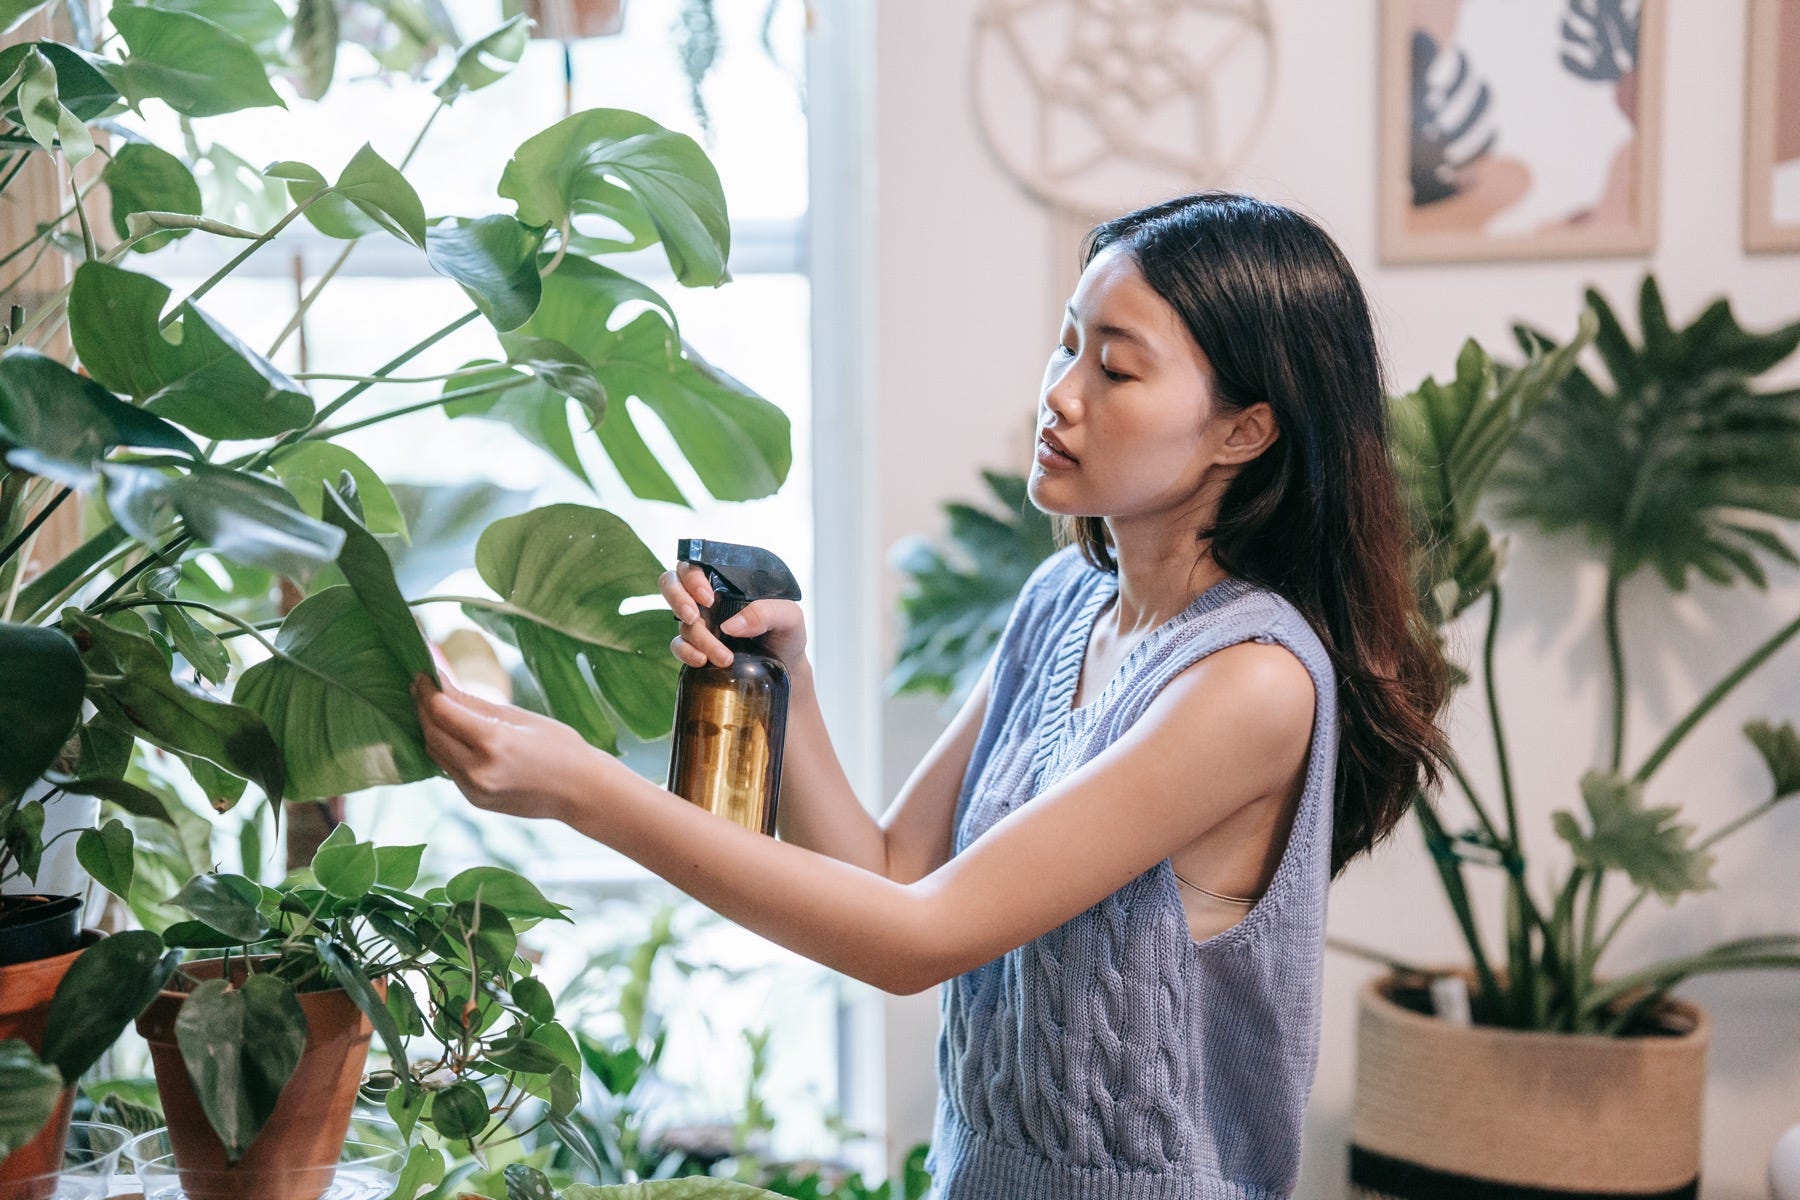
left=927, top=547, right=1337, bottom=1200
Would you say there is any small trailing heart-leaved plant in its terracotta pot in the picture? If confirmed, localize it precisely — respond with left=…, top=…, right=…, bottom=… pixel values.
left=137, top=826, right=581, bottom=1200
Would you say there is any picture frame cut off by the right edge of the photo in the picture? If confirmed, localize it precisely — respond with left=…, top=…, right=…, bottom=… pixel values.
left=1744, top=0, right=1800, bottom=254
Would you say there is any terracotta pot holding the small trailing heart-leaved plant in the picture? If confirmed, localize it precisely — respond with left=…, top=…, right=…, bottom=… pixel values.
left=137, top=959, right=387, bottom=1200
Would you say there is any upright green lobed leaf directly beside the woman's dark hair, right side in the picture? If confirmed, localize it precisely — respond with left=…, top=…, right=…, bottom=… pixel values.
left=1388, top=318, right=1595, bottom=622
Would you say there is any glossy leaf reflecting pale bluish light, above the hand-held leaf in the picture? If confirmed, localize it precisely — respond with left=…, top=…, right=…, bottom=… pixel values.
left=101, top=462, right=344, bottom=581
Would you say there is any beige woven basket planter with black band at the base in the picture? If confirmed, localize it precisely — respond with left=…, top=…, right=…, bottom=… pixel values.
left=1350, top=975, right=1712, bottom=1200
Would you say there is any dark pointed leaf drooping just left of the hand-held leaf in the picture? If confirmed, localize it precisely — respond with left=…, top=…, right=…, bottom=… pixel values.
left=63, top=608, right=283, bottom=801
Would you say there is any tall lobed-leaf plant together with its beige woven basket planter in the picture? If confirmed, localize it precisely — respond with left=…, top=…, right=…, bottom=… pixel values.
left=1336, top=277, right=1800, bottom=1196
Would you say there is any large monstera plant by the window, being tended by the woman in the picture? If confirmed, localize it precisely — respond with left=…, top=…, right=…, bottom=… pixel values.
left=0, top=0, right=790, bottom=1187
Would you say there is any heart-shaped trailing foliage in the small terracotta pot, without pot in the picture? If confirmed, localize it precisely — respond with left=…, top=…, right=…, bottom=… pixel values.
left=150, top=826, right=587, bottom=1196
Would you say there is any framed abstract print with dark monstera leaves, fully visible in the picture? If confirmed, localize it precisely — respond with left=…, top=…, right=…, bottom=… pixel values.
left=1377, top=0, right=1665, bottom=264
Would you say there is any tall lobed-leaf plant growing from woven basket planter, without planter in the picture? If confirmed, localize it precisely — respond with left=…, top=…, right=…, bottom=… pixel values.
left=1368, top=277, right=1800, bottom=1034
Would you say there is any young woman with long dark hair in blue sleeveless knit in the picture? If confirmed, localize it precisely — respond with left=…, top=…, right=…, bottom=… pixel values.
left=416, top=193, right=1445, bottom=1200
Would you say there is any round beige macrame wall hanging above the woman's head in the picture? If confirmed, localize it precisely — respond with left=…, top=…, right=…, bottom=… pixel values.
left=970, top=0, right=1276, bottom=293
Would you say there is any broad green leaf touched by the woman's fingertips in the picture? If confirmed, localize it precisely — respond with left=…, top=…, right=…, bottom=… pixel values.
left=236, top=587, right=437, bottom=799
